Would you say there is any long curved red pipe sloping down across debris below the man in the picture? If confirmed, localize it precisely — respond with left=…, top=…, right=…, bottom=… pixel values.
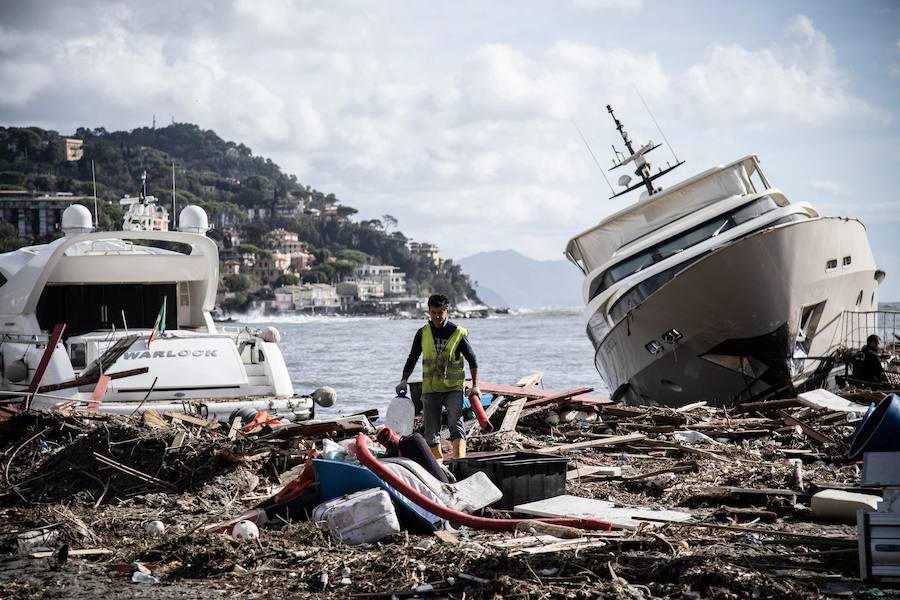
left=356, top=433, right=612, bottom=531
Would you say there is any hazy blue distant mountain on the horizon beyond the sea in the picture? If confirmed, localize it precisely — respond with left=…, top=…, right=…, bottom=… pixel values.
left=457, top=250, right=583, bottom=308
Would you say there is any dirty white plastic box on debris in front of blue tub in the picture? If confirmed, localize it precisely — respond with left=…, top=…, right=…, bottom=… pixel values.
left=313, top=488, right=400, bottom=546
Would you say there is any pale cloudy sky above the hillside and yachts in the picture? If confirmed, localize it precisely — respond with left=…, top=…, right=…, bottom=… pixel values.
left=0, top=0, right=900, bottom=300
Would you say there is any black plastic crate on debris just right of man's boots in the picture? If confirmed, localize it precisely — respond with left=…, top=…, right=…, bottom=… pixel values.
left=450, top=452, right=569, bottom=510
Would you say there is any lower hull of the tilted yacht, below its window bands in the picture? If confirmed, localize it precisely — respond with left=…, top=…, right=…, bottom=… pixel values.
left=585, top=218, right=878, bottom=406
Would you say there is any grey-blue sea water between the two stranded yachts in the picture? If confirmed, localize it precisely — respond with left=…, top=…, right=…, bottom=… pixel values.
left=240, top=310, right=609, bottom=418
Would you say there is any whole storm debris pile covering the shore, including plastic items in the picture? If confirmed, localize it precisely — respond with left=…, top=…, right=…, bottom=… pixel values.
left=0, top=385, right=900, bottom=598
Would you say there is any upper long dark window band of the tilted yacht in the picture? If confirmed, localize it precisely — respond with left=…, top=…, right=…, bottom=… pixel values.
left=591, top=196, right=779, bottom=298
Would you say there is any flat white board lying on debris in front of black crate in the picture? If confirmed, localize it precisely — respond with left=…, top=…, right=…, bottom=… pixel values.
left=513, top=494, right=691, bottom=529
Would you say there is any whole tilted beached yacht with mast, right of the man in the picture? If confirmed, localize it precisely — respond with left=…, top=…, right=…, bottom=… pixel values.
left=566, top=106, right=884, bottom=406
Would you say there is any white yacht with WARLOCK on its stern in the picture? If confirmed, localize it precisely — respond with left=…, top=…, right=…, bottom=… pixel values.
left=0, top=185, right=333, bottom=420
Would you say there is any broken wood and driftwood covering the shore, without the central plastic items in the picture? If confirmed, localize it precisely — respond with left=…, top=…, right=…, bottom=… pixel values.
left=0, top=386, right=880, bottom=598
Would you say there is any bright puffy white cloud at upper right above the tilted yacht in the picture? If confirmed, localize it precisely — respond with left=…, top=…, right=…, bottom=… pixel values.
left=684, top=15, right=883, bottom=124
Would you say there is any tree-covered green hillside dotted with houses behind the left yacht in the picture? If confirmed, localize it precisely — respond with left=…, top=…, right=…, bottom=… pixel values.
left=0, top=123, right=475, bottom=302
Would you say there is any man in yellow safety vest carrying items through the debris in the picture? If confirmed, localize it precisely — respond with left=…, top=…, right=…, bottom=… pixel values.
left=396, top=294, right=481, bottom=460
